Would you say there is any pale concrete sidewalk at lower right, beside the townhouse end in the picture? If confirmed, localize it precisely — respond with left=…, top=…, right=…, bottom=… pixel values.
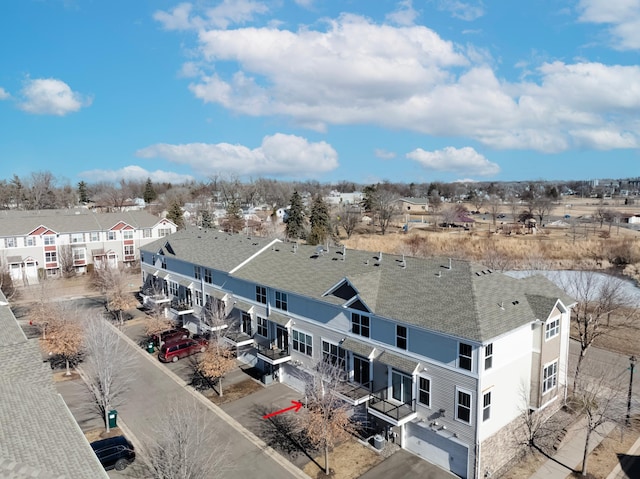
left=529, top=419, right=625, bottom=479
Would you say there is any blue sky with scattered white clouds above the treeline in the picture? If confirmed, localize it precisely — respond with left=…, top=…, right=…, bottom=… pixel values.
left=0, top=0, right=640, bottom=185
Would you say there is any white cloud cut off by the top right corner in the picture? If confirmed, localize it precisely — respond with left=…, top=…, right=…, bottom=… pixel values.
left=578, top=0, right=640, bottom=50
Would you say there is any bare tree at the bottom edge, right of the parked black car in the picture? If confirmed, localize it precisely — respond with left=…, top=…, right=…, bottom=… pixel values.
left=141, top=398, right=229, bottom=479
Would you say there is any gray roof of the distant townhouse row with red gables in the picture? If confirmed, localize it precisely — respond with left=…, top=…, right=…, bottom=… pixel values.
left=0, top=208, right=161, bottom=236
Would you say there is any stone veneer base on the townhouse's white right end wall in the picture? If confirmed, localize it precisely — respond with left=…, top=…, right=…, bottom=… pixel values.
left=479, top=398, right=562, bottom=478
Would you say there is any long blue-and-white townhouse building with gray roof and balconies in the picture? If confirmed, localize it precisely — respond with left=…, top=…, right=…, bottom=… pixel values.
left=140, top=230, right=573, bottom=478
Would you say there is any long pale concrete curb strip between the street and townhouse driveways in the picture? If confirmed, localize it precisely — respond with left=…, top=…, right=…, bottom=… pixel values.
left=108, top=322, right=311, bottom=479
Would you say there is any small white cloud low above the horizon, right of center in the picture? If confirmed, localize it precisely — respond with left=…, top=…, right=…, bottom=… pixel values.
left=407, top=146, right=500, bottom=176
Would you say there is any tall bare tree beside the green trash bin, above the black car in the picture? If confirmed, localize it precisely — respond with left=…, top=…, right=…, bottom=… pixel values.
left=82, top=314, right=134, bottom=432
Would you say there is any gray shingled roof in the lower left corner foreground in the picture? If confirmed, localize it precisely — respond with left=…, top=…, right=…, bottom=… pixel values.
left=0, top=292, right=109, bottom=479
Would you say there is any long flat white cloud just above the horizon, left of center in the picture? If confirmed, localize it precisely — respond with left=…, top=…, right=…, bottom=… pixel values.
left=136, top=133, right=338, bottom=177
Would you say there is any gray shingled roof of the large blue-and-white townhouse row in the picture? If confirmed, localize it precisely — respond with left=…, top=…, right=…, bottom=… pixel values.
left=147, top=232, right=573, bottom=342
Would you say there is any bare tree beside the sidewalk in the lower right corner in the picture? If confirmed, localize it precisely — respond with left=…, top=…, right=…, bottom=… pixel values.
left=570, top=368, right=624, bottom=476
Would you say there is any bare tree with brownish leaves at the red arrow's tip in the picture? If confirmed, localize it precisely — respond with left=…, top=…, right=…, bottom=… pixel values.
left=296, top=360, right=356, bottom=474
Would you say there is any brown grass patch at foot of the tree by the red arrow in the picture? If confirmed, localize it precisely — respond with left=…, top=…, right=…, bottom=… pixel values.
left=303, top=440, right=382, bottom=479
